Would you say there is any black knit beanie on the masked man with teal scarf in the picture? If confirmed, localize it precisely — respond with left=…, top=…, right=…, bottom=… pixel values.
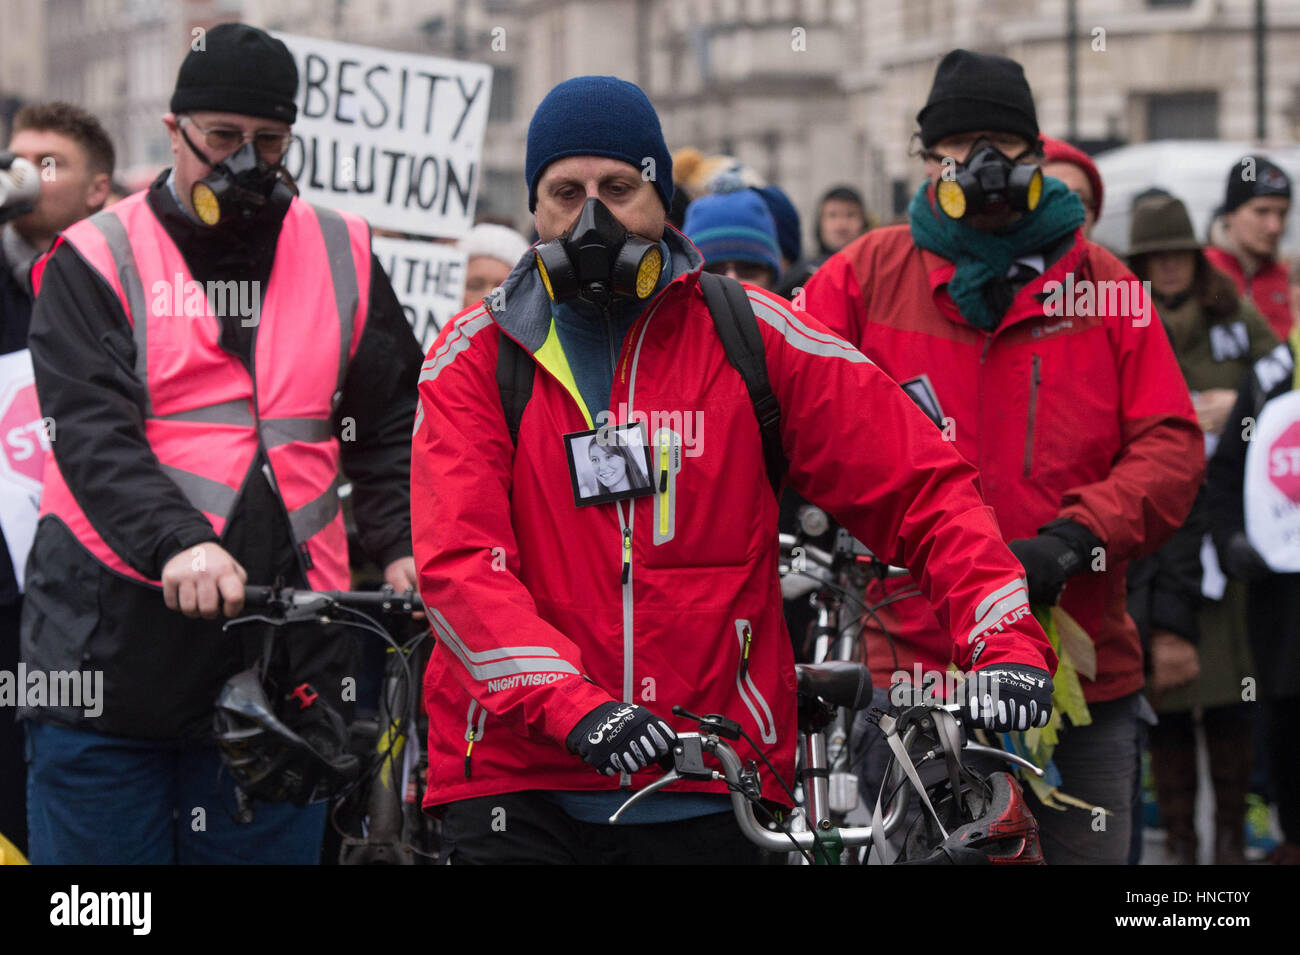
left=917, top=49, right=1039, bottom=148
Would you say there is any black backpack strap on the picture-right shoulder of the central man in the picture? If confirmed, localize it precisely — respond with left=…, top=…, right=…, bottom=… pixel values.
left=699, top=272, right=787, bottom=495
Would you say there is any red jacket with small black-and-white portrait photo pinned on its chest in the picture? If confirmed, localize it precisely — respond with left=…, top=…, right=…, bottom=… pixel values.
left=411, top=227, right=1056, bottom=807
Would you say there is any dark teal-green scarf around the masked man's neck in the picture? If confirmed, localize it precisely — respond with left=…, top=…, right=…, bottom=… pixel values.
left=907, top=177, right=1083, bottom=331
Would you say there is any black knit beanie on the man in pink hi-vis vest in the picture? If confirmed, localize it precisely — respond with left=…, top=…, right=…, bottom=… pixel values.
left=172, top=23, right=298, bottom=123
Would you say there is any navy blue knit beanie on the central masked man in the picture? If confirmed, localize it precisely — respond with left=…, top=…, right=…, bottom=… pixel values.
left=524, top=77, right=672, bottom=212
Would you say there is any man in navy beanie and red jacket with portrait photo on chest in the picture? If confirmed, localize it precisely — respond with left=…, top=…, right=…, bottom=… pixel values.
left=411, top=77, right=1056, bottom=864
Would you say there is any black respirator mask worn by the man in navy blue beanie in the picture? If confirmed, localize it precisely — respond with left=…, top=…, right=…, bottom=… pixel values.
left=533, top=199, right=663, bottom=312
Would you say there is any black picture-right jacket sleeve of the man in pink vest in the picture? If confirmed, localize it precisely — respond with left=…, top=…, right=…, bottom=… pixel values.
left=335, top=256, right=424, bottom=568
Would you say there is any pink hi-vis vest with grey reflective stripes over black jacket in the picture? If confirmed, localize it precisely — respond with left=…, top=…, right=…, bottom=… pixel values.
left=33, top=192, right=371, bottom=590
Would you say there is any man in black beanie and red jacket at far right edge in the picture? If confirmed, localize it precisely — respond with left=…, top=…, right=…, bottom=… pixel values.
left=1205, top=156, right=1291, bottom=342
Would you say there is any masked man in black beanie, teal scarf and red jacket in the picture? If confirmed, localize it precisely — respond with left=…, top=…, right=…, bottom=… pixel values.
left=806, top=49, right=1203, bottom=863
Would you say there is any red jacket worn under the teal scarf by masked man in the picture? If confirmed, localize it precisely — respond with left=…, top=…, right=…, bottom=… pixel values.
left=805, top=210, right=1204, bottom=702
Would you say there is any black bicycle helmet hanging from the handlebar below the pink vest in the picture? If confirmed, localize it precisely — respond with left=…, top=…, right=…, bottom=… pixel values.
left=215, top=669, right=360, bottom=806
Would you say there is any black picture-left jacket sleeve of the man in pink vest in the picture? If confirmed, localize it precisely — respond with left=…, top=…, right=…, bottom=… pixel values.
left=27, top=244, right=218, bottom=579
